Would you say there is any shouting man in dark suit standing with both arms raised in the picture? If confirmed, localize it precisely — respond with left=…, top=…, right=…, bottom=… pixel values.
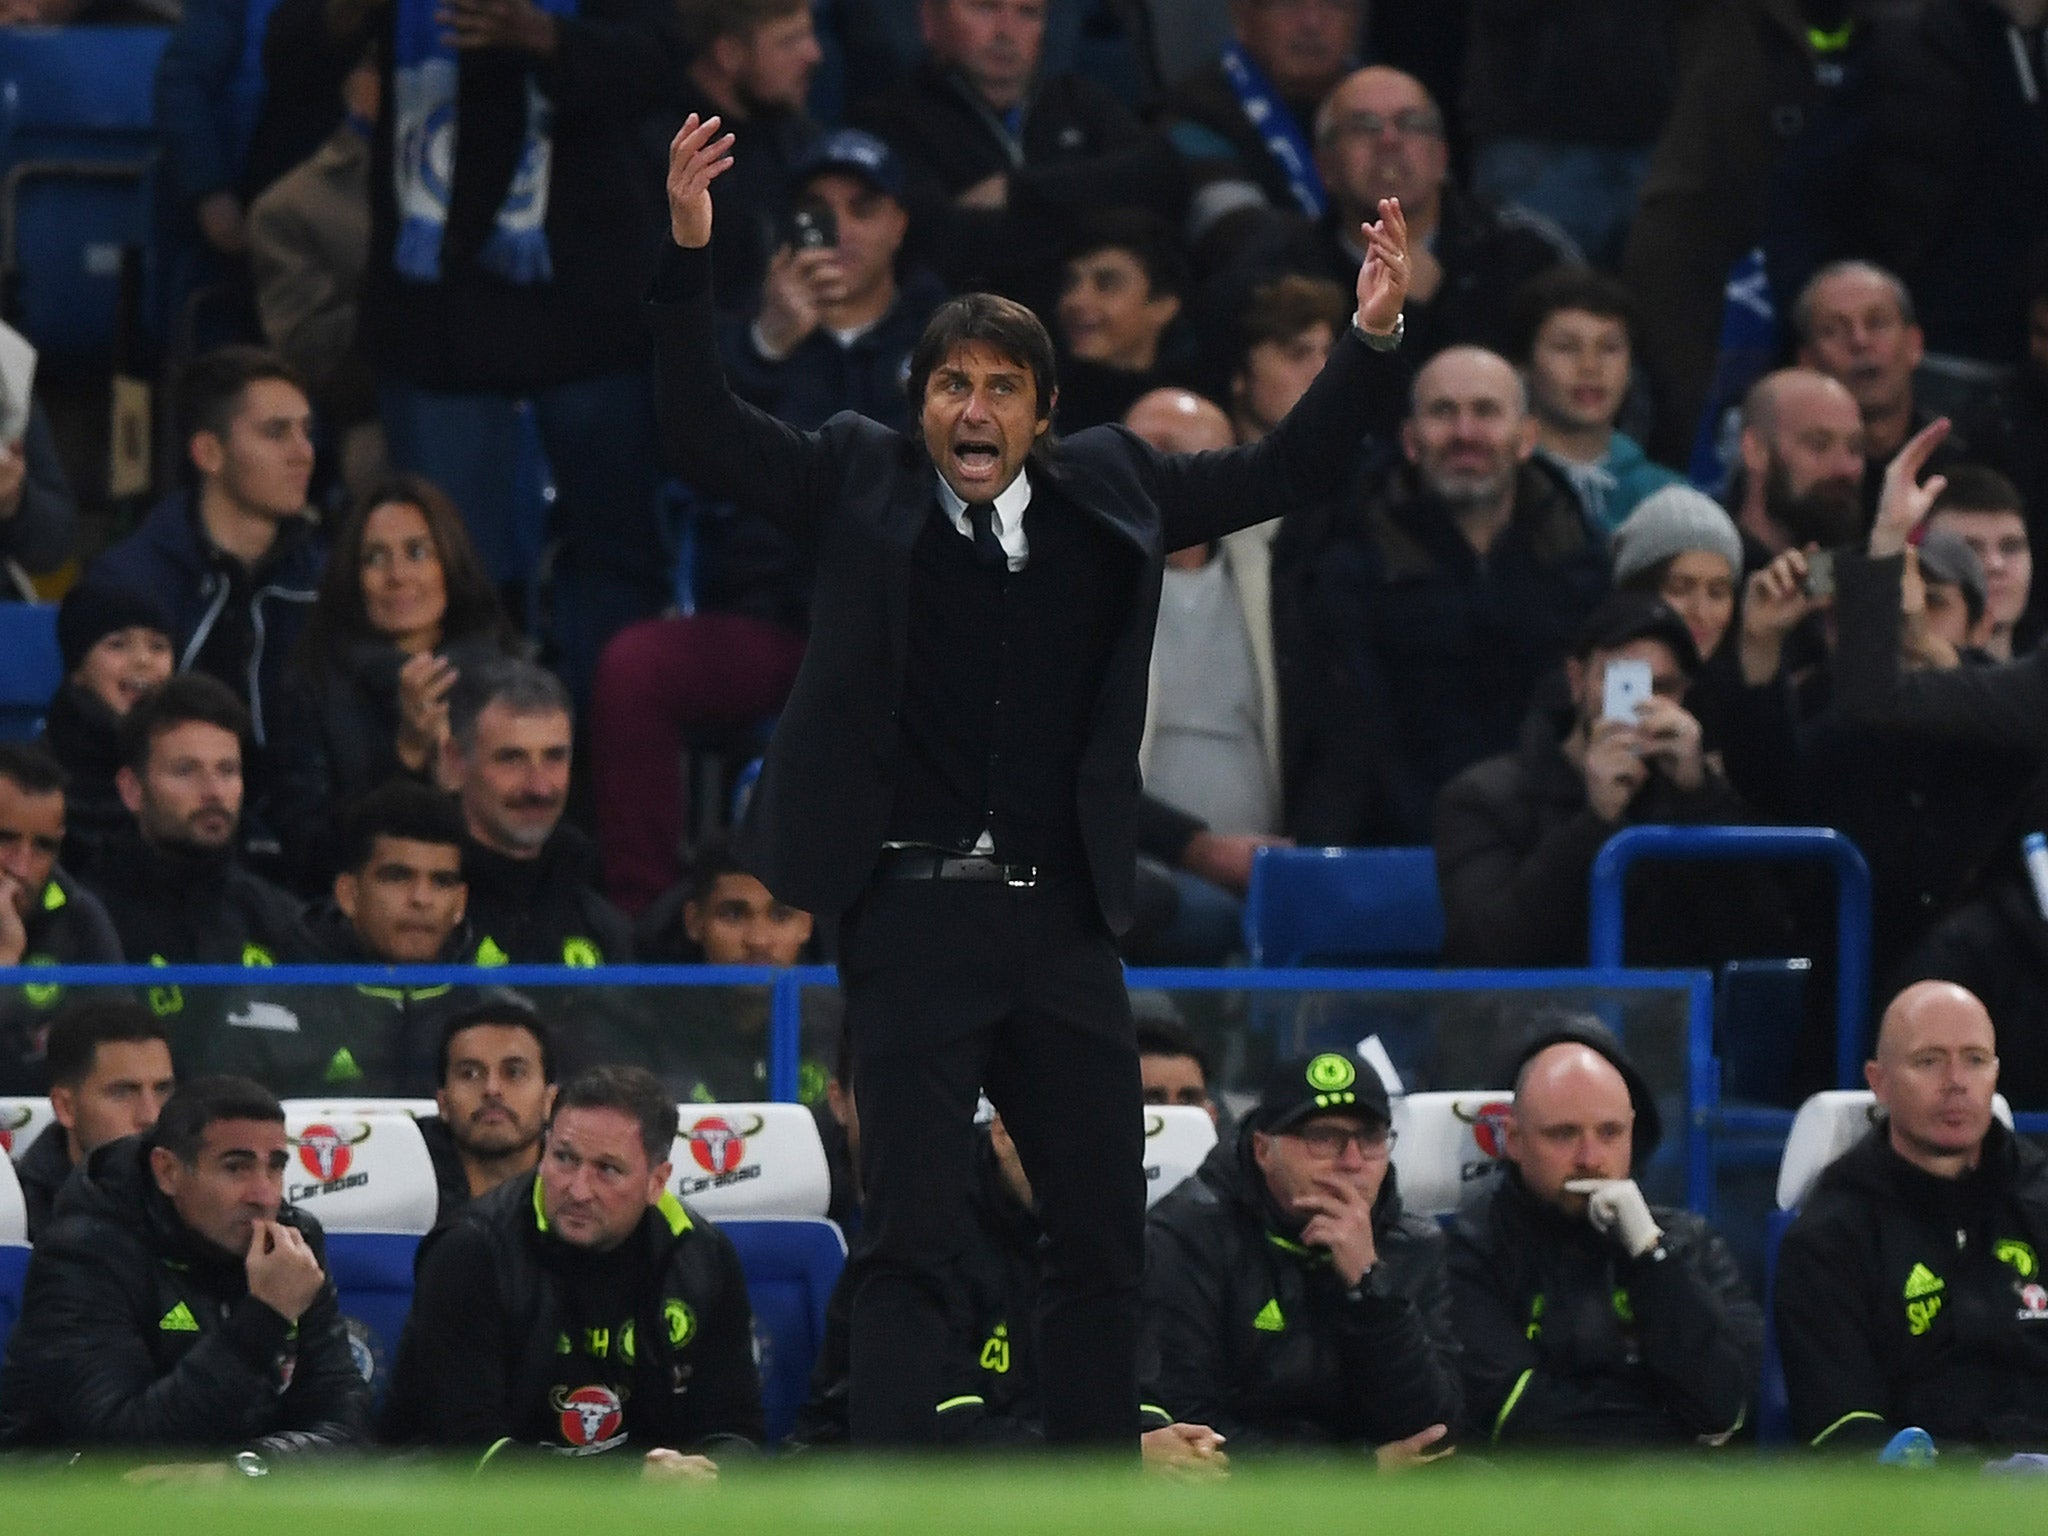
left=653, top=119, right=1407, bottom=1454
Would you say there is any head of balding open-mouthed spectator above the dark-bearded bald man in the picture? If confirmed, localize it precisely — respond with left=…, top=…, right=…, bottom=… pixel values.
left=1792, top=262, right=1962, bottom=516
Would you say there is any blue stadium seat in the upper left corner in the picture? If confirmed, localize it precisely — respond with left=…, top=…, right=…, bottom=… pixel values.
left=0, top=27, right=170, bottom=369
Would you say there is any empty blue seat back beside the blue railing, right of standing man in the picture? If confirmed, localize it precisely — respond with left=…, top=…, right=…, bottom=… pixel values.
left=1245, top=848, right=1444, bottom=967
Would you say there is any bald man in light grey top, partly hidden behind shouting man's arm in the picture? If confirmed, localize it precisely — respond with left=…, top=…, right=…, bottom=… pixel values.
left=1124, top=389, right=1282, bottom=965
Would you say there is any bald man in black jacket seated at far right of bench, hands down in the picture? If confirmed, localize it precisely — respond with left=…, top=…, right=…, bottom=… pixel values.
left=1776, top=981, right=2048, bottom=1450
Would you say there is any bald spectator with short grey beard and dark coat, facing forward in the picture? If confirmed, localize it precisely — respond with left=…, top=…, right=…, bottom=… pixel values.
left=1292, top=346, right=1608, bottom=844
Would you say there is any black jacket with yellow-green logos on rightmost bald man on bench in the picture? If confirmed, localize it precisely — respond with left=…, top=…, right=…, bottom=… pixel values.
left=1776, top=1122, right=2048, bottom=1450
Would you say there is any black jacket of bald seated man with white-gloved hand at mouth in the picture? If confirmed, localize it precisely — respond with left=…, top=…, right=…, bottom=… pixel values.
left=1450, top=1167, right=1763, bottom=1446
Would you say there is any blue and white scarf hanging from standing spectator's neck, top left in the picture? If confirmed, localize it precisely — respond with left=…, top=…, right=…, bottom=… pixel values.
left=391, top=0, right=575, bottom=283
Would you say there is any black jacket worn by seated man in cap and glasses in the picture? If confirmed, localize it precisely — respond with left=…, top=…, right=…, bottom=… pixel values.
left=1145, top=1126, right=1460, bottom=1456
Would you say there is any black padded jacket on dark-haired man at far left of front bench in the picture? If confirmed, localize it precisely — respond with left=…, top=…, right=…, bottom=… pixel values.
left=0, top=1137, right=371, bottom=1454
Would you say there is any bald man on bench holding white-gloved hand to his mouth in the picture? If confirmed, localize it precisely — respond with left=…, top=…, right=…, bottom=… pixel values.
left=1450, top=1024, right=1763, bottom=1446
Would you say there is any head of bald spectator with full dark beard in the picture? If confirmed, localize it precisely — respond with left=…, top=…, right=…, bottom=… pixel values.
left=1729, top=369, right=1864, bottom=569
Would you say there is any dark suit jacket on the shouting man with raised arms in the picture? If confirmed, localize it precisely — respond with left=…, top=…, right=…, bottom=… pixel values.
left=653, top=248, right=1389, bottom=932
